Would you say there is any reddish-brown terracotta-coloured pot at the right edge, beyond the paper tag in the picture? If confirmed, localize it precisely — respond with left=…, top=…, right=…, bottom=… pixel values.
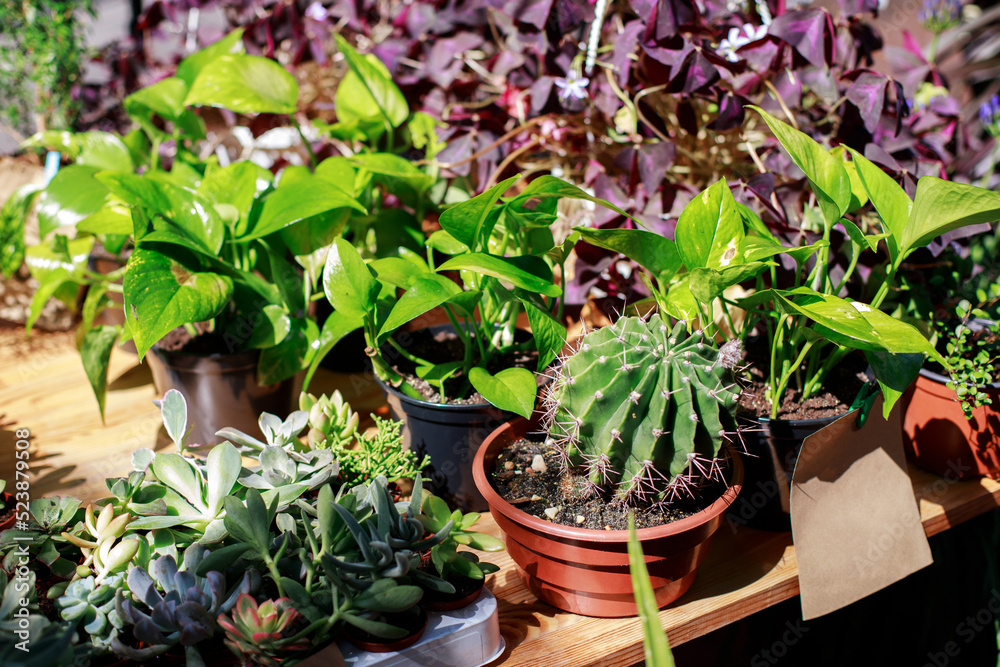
left=903, top=369, right=1000, bottom=480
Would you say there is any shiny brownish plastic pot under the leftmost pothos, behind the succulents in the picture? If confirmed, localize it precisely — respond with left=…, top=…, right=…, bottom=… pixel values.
left=146, top=347, right=302, bottom=445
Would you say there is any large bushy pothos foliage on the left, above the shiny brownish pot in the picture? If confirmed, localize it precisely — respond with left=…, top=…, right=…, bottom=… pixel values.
left=7, top=31, right=367, bottom=415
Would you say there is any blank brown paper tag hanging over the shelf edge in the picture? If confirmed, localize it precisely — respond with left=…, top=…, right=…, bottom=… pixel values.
left=791, top=397, right=932, bottom=620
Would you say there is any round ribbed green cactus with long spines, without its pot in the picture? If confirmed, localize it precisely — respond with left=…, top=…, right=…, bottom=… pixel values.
left=545, top=315, right=740, bottom=504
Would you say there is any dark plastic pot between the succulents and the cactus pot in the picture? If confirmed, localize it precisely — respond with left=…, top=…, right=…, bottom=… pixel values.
left=379, top=380, right=515, bottom=511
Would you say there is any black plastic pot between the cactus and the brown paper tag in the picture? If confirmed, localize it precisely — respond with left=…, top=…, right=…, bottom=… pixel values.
left=726, top=415, right=844, bottom=531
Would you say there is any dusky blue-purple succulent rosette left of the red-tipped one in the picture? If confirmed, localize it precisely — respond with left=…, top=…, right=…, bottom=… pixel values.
left=111, top=544, right=259, bottom=665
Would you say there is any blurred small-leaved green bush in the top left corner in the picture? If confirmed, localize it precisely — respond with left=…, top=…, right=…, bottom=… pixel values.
left=0, top=0, right=95, bottom=135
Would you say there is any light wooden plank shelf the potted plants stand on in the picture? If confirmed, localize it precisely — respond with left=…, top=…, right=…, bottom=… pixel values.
left=0, top=328, right=1000, bottom=666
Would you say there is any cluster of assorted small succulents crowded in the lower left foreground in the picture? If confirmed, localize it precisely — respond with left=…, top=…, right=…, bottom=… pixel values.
left=0, top=388, right=502, bottom=667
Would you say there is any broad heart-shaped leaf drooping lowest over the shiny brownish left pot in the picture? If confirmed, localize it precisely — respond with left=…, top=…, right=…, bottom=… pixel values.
left=124, top=246, right=233, bottom=358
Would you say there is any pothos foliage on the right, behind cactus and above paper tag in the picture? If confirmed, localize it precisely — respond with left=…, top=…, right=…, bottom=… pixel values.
left=578, top=109, right=1000, bottom=418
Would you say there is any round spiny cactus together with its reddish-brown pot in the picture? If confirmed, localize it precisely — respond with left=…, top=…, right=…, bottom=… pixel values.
left=473, top=315, right=743, bottom=616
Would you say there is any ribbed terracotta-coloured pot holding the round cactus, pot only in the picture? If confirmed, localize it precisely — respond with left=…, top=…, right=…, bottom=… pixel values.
left=473, top=419, right=743, bottom=617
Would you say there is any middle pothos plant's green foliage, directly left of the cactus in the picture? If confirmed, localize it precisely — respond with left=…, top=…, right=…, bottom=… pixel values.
left=318, top=175, right=621, bottom=416
